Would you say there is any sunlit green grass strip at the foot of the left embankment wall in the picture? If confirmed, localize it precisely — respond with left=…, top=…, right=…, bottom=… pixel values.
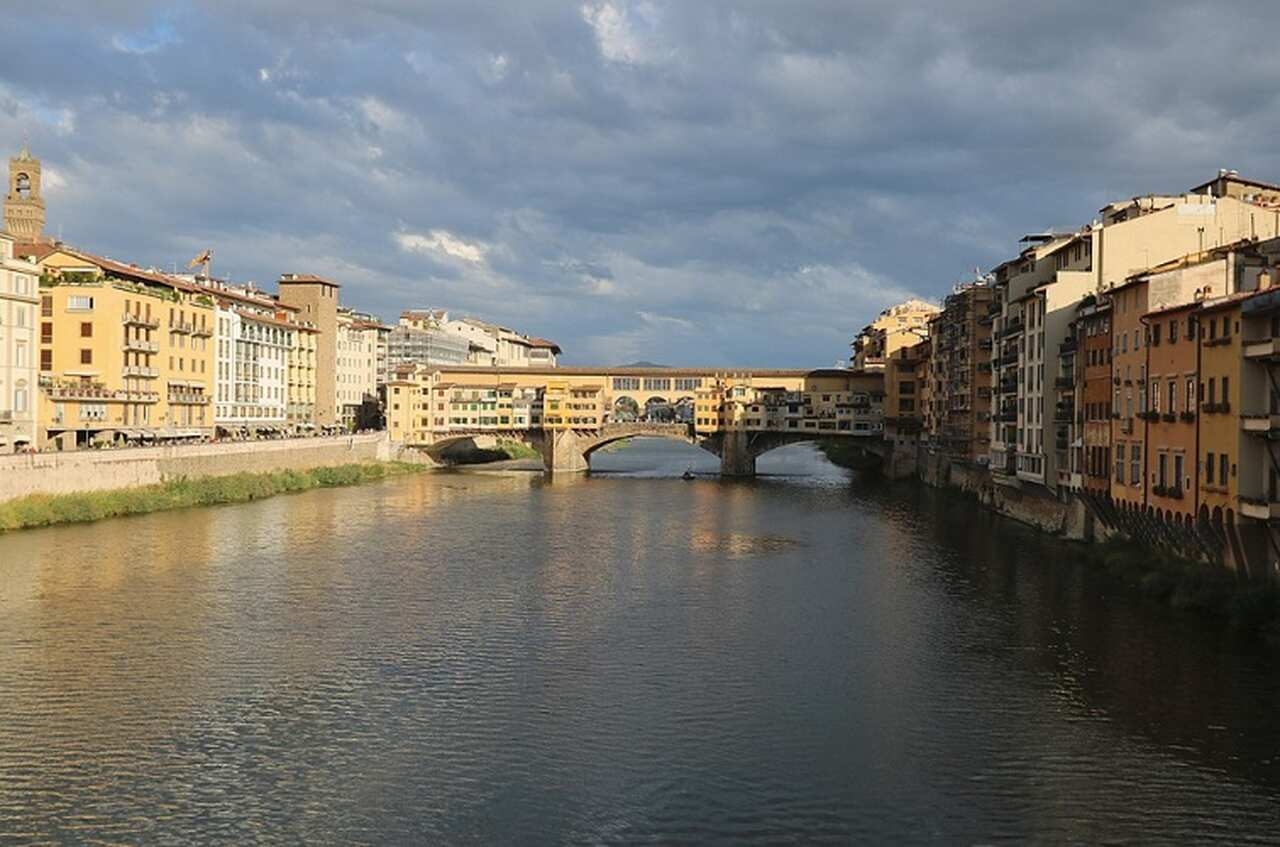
left=0, top=462, right=426, bottom=532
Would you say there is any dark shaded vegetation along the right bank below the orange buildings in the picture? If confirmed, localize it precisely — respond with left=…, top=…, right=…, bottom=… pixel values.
left=1083, top=540, right=1280, bottom=644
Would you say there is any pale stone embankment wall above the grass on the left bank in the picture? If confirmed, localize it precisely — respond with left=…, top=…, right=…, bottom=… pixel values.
left=0, top=432, right=431, bottom=503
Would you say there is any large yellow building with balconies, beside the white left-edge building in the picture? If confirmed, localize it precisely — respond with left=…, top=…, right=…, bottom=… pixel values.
left=23, top=244, right=215, bottom=449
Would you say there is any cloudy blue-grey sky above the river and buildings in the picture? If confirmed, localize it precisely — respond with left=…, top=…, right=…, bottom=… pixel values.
left=0, top=0, right=1280, bottom=367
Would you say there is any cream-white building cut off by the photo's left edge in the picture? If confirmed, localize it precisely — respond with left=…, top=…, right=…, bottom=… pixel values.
left=0, top=233, right=40, bottom=453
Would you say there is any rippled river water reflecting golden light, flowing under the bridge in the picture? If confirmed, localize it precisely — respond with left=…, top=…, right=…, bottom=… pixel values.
left=0, top=443, right=1280, bottom=844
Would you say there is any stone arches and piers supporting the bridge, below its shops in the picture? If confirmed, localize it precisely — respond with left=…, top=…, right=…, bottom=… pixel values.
left=425, top=421, right=886, bottom=477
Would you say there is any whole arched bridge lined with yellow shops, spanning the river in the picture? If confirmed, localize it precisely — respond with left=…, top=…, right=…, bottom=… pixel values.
left=387, top=366, right=886, bottom=476
